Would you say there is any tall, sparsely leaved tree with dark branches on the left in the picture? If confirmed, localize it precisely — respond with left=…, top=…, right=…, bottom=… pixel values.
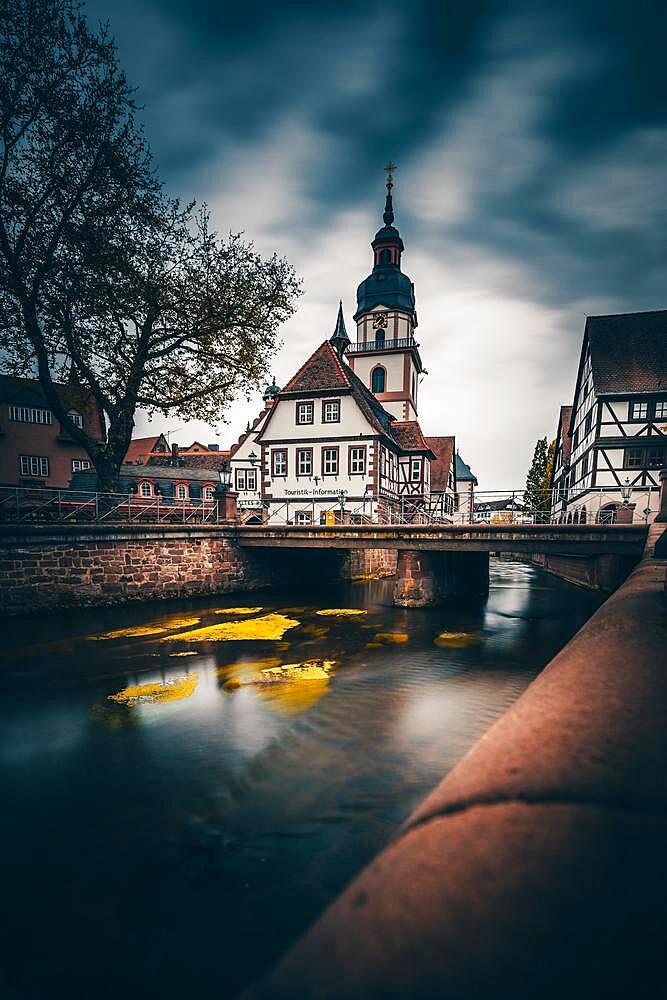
left=0, top=0, right=300, bottom=489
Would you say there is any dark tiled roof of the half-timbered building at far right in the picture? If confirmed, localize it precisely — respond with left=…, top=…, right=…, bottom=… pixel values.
left=585, top=309, right=667, bottom=395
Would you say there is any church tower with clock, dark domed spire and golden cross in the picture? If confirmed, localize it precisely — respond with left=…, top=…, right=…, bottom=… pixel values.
left=346, top=163, right=424, bottom=420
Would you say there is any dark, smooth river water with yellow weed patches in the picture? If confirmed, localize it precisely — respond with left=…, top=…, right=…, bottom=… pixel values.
left=0, top=560, right=599, bottom=1000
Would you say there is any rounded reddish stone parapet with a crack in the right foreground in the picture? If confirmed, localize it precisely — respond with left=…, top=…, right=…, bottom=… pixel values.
left=246, top=559, right=667, bottom=1000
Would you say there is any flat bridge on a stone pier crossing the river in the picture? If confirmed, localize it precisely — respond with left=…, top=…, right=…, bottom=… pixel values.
left=237, top=524, right=648, bottom=607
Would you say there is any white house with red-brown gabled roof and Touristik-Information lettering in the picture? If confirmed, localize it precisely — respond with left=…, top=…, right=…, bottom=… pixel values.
left=256, top=330, right=435, bottom=523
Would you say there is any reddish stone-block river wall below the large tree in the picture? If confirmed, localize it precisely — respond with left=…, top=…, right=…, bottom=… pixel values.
left=0, top=525, right=276, bottom=614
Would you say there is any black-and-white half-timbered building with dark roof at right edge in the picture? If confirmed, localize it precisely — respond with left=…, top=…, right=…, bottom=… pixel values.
left=552, top=310, right=667, bottom=523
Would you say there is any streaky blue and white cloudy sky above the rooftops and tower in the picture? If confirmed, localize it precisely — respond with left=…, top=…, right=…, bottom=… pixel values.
left=88, top=0, right=667, bottom=489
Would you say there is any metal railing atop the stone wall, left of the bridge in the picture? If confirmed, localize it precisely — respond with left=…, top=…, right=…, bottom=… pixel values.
left=0, top=486, right=225, bottom=524
